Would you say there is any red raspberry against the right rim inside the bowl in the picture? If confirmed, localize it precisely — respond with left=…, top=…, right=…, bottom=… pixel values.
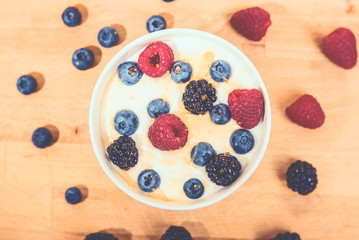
left=228, top=89, right=264, bottom=129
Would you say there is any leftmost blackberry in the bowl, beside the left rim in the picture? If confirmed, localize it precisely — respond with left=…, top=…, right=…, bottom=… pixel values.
left=107, top=136, right=138, bottom=170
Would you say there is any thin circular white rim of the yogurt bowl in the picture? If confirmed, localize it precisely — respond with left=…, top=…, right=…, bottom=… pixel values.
left=89, top=28, right=271, bottom=210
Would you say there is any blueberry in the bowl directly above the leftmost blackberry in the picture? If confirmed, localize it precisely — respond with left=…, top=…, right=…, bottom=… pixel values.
left=114, top=110, right=138, bottom=136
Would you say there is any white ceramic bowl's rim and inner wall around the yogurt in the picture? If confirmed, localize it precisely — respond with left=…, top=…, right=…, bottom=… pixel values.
left=89, top=29, right=271, bottom=210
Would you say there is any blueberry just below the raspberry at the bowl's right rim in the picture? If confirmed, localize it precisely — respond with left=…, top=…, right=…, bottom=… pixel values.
left=230, top=129, right=254, bottom=154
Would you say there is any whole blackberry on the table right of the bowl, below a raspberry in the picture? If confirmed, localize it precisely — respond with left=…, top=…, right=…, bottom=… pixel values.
left=287, top=160, right=318, bottom=195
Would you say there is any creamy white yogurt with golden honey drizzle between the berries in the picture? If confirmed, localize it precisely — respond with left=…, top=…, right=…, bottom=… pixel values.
left=100, top=36, right=264, bottom=202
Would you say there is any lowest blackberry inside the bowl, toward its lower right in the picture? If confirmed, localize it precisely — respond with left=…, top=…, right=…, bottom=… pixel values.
left=206, top=153, right=242, bottom=187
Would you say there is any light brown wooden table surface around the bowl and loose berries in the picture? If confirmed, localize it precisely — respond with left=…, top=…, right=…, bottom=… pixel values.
left=0, top=0, right=359, bottom=240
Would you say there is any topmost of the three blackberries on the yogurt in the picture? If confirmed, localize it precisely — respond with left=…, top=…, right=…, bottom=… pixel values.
left=182, top=79, right=217, bottom=114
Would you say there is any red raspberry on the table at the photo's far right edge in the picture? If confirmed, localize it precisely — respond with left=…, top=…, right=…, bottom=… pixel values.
left=322, top=28, right=357, bottom=69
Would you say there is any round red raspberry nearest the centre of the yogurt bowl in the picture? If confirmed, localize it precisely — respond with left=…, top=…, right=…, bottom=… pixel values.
left=148, top=113, right=188, bottom=151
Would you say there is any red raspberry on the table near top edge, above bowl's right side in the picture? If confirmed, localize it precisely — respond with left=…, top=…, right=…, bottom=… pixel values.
left=230, top=7, right=272, bottom=41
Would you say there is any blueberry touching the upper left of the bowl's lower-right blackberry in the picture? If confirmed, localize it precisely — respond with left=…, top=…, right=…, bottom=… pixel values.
left=191, top=142, right=215, bottom=166
